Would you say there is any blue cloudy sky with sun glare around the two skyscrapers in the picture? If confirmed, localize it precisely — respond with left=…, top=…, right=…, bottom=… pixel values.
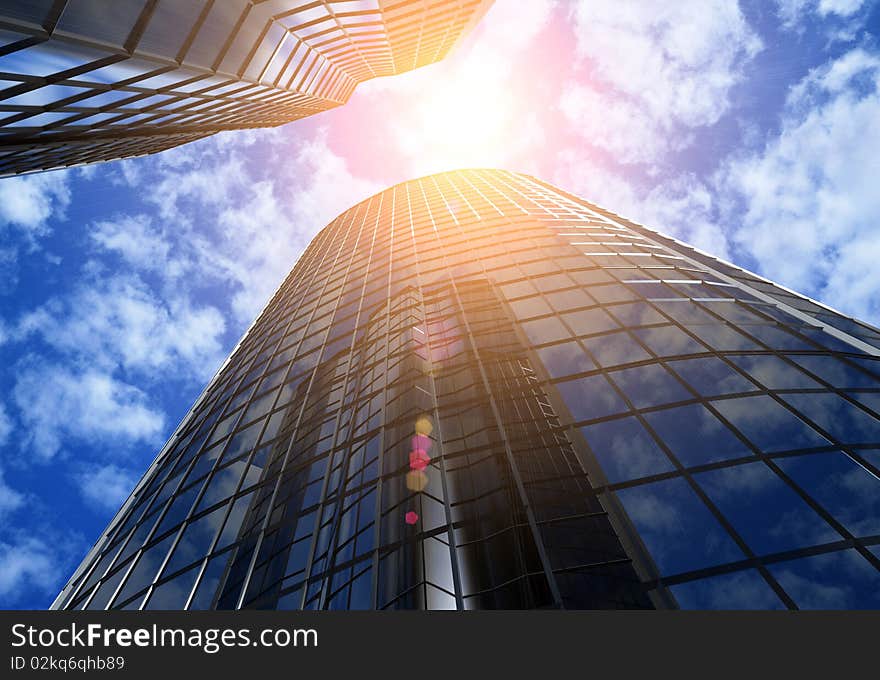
left=0, top=0, right=880, bottom=608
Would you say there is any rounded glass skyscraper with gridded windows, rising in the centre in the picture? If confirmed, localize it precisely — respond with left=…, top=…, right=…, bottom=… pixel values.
left=53, top=170, right=880, bottom=609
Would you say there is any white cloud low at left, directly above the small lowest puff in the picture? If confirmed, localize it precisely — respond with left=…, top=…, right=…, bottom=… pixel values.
left=13, top=357, right=165, bottom=461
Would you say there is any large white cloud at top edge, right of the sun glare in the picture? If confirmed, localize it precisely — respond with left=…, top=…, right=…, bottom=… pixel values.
left=560, top=0, right=762, bottom=163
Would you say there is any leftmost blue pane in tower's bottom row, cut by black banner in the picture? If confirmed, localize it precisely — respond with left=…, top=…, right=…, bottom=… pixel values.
left=672, top=570, right=785, bottom=609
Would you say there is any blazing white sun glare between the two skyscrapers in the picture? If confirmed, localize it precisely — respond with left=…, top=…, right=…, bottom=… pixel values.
left=352, top=0, right=556, bottom=178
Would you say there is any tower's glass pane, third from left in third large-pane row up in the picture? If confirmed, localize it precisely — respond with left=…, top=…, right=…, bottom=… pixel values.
left=712, top=395, right=829, bottom=452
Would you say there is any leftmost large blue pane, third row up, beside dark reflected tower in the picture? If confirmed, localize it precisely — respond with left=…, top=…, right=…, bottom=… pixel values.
left=581, top=417, right=672, bottom=483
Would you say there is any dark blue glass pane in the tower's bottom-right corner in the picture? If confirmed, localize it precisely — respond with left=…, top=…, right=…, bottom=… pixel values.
left=769, top=550, right=880, bottom=609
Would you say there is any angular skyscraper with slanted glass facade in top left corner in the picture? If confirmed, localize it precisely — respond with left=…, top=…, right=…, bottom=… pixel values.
left=0, top=0, right=491, bottom=177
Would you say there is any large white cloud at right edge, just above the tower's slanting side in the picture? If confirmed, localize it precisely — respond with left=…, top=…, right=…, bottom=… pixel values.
left=727, top=49, right=880, bottom=322
